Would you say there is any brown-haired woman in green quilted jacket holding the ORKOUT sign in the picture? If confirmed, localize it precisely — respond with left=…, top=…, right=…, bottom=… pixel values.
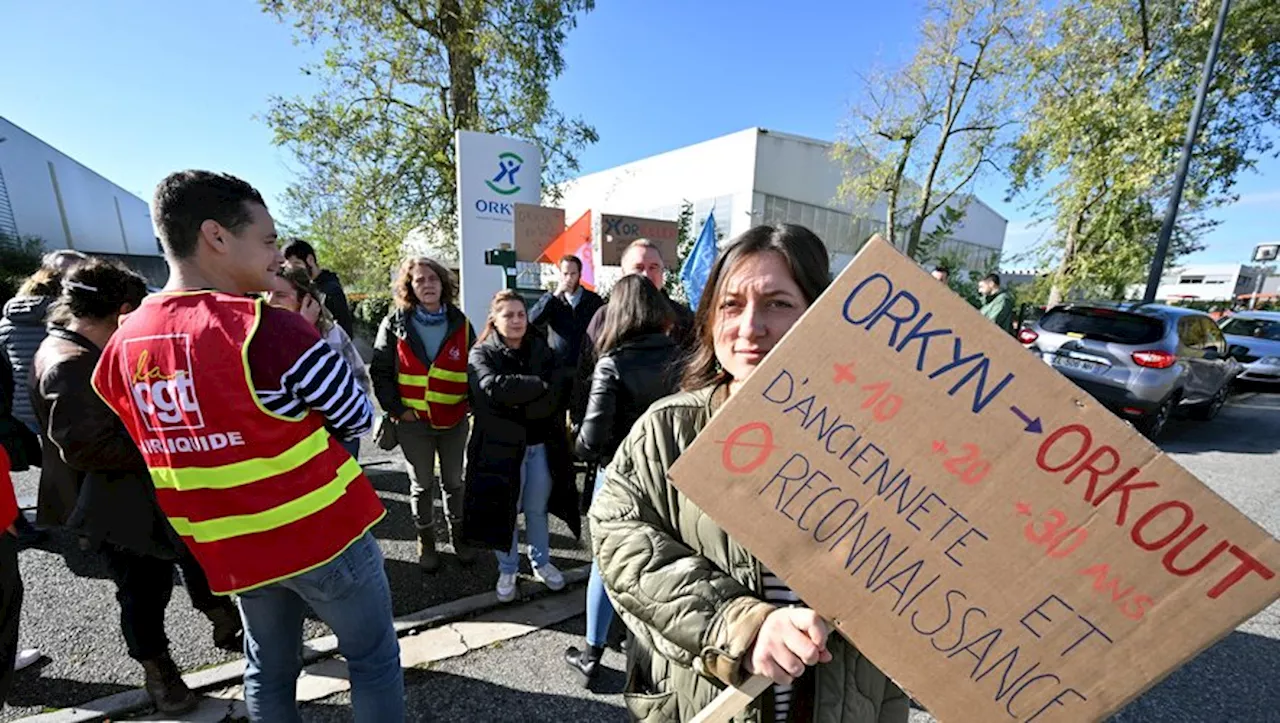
left=590, top=224, right=909, bottom=723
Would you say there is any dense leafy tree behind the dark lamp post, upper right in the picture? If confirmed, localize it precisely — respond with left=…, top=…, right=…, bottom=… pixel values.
left=1011, top=0, right=1280, bottom=305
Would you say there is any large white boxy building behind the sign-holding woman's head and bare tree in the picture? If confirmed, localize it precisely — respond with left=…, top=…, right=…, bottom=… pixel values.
left=557, top=128, right=1007, bottom=271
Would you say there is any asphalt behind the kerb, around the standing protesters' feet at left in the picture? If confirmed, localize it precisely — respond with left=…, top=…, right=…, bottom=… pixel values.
left=0, top=440, right=590, bottom=722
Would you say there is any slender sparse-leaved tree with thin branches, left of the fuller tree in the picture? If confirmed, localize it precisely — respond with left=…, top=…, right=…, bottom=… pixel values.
left=835, top=0, right=1037, bottom=261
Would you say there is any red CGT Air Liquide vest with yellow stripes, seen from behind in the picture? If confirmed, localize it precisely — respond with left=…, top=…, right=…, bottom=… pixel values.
left=93, top=292, right=387, bottom=594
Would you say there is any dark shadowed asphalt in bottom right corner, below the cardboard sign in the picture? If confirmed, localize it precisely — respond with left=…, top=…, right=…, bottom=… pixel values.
left=1112, top=632, right=1280, bottom=723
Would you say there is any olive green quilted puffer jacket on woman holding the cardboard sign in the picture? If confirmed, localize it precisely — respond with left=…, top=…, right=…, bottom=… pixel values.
left=590, top=388, right=909, bottom=723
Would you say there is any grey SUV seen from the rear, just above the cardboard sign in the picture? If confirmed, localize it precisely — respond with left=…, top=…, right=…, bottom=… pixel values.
left=1018, top=303, right=1242, bottom=439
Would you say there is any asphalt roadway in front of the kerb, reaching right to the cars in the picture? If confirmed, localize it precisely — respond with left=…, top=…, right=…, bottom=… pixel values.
left=303, top=393, right=1280, bottom=723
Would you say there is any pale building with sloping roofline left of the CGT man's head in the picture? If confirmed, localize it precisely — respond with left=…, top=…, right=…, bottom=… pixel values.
left=0, top=118, right=168, bottom=284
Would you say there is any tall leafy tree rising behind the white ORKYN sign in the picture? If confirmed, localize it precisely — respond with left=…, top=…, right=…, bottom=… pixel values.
left=261, top=0, right=598, bottom=288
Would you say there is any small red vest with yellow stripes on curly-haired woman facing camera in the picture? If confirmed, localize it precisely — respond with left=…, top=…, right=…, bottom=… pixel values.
left=396, top=321, right=471, bottom=429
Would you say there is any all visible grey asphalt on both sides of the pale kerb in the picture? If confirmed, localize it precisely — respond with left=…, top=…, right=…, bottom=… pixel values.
left=0, top=392, right=1280, bottom=723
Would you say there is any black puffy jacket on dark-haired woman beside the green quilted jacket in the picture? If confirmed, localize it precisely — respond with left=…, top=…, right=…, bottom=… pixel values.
left=573, top=334, right=680, bottom=465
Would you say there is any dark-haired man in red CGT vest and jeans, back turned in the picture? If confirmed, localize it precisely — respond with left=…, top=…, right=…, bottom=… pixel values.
left=93, top=170, right=404, bottom=723
